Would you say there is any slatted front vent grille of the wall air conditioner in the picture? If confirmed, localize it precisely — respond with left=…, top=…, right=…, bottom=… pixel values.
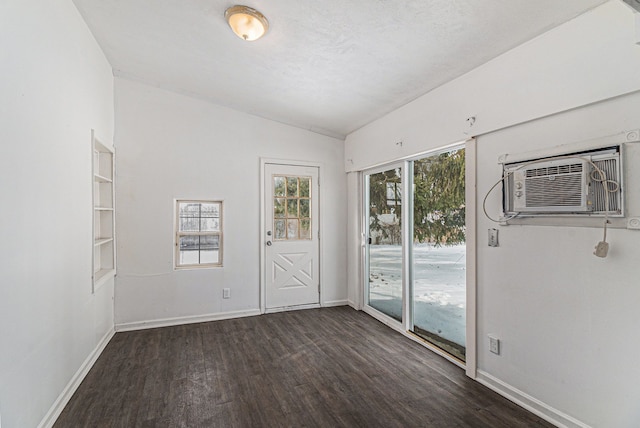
left=526, top=174, right=582, bottom=208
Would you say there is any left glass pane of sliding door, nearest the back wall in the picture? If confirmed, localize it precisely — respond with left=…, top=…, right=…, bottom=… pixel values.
left=366, top=168, right=403, bottom=321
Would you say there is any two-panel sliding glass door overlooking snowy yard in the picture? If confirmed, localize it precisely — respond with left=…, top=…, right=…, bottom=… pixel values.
left=365, top=146, right=466, bottom=361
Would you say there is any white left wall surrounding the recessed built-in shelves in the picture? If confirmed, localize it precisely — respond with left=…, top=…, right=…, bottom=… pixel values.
left=0, top=0, right=113, bottom=428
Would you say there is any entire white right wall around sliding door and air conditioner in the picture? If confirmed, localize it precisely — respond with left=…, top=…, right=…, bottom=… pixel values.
left=345, top=0, right=640, bottom=427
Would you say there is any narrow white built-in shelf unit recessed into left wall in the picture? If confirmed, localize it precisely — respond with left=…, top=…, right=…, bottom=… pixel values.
left=91, top=131, right=116, bottom=292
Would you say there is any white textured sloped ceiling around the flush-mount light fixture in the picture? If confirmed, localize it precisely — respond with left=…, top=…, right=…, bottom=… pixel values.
left=73, top=0, right=607, bottom=137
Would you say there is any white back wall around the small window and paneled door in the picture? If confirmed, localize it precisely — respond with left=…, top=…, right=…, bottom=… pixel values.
left=115, top=78, right=347, bottom=328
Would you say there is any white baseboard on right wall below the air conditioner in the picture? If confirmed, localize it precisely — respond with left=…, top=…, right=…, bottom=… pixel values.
left=475, top=370, right=590, bottom=428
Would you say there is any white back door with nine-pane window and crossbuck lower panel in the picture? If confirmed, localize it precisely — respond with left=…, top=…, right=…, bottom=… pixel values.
left=263, top=164, right=320, bottom=310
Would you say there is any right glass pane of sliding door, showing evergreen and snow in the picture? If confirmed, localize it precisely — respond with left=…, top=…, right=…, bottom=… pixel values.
left=410, top=148, right=466, bottom=361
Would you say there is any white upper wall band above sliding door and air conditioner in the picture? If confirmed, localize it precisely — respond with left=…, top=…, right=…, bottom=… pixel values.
left=345, top=0, right=640, bottom=171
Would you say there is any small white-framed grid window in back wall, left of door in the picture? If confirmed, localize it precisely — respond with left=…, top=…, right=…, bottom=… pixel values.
left=175, top=201, right=222, bottom=268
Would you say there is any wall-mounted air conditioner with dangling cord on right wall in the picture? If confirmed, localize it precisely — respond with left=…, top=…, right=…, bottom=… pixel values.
left=503, top=147, right=623, bottom=216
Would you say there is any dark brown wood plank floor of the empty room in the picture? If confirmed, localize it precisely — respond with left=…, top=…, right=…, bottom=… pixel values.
left=55, top=307, right=551, bottom=428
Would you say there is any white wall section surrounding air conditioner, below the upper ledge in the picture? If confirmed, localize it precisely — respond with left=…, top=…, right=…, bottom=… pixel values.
left=477, top=93, right=640, bottom=428
